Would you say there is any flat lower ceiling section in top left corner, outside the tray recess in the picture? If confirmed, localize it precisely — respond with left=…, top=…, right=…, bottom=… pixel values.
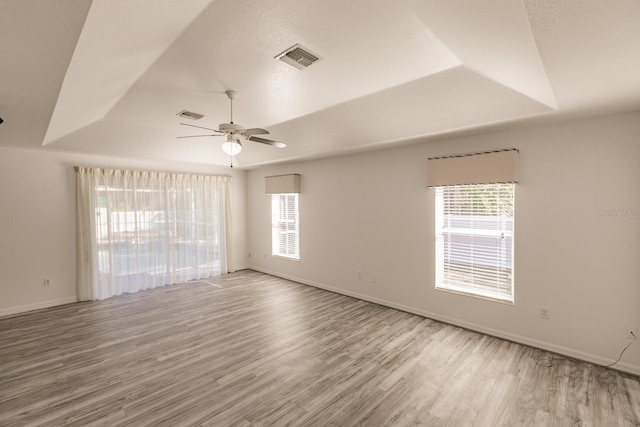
left=0, top=0, right=91, bottom=148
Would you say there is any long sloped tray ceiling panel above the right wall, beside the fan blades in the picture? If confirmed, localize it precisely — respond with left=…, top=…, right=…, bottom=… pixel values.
left=238, top=65, right=550, bottom=164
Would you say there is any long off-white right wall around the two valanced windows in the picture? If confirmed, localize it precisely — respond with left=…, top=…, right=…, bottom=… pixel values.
left=247, top=113, right=640, bottom=374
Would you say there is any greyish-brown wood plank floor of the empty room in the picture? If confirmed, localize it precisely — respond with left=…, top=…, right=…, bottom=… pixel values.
left=0, top=271, right=640, bottom=427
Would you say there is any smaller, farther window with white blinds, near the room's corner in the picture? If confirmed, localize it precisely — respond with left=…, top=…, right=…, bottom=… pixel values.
left=271, top=193, right=300, bottom=259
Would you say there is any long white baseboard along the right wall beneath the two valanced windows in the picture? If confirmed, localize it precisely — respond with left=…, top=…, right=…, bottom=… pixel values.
left=249, top=267, right=640, bottom=375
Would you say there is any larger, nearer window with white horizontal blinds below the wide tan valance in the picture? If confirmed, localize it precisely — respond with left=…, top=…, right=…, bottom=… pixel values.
left=436, top=184, right=515, bottom=302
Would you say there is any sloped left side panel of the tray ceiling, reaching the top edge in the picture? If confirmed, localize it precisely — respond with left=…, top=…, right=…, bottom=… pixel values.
left=43, top=0, right=210, bottom=144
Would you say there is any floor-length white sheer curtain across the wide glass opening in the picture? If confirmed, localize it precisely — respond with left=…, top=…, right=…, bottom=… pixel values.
left=76, top=167, right=231, bottom=301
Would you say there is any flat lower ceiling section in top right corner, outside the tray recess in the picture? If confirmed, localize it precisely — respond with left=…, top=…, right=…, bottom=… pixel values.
left=523, top=0, right=640, bottom=112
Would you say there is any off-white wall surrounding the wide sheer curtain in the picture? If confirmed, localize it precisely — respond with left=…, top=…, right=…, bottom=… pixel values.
left=0, top=148, right=247, bottom=316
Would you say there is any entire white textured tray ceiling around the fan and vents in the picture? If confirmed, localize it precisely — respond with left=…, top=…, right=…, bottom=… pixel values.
left=0, top=0, right=640, bottom=167
